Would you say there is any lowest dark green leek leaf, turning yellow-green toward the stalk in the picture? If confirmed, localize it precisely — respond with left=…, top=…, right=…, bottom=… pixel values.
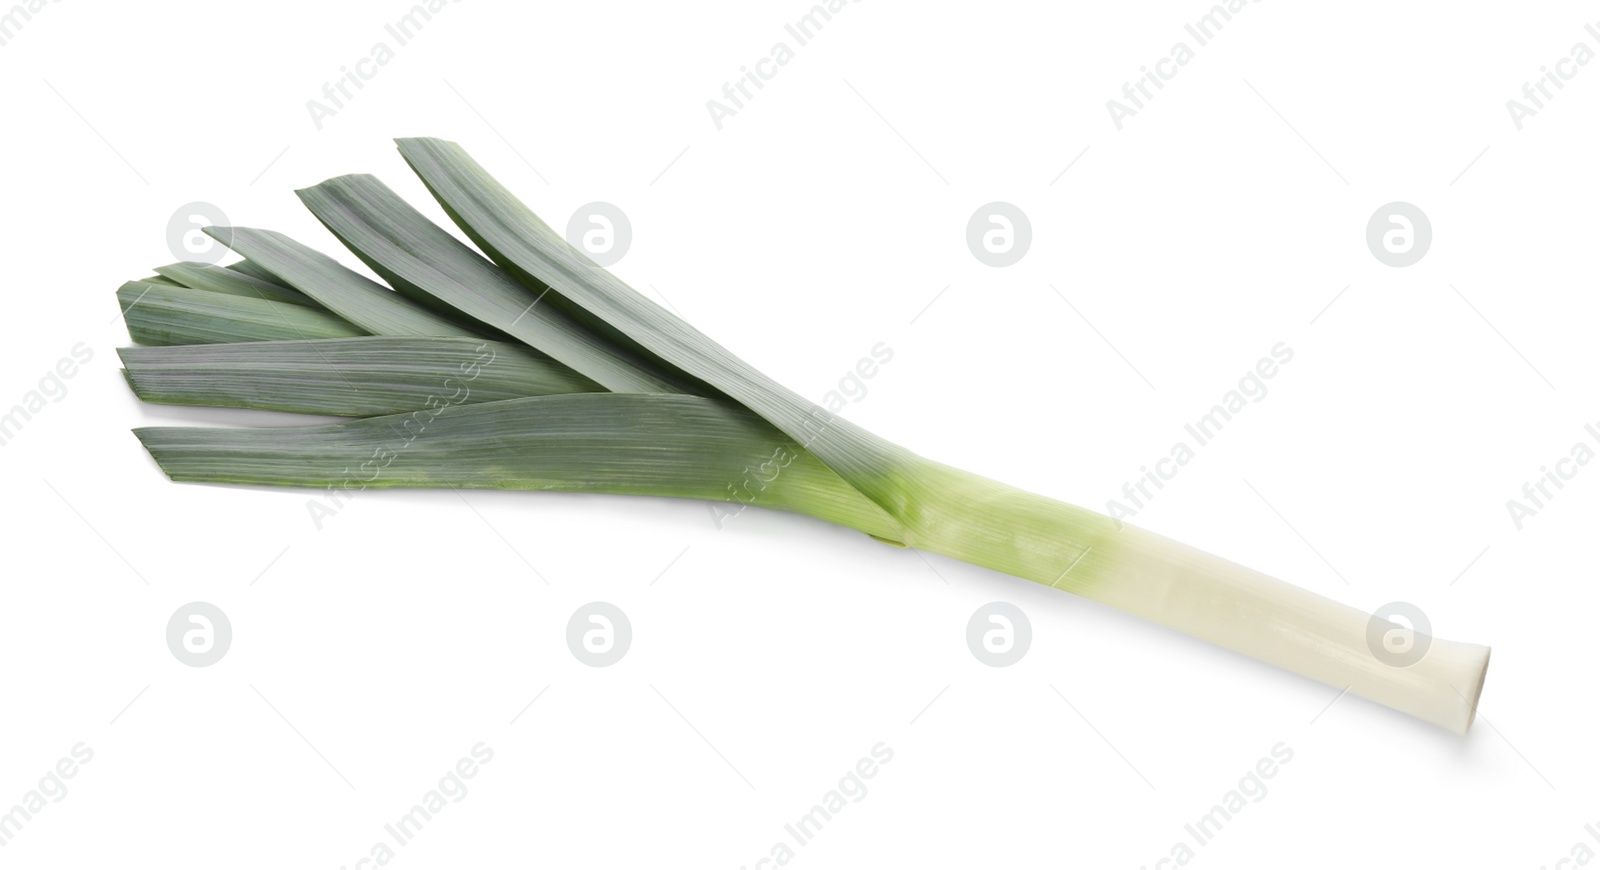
left=134, top=393, right=898, bottom=541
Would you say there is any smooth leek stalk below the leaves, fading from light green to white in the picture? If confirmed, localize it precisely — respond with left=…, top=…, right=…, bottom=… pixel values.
left=899, top=462, right=1490, bottom=732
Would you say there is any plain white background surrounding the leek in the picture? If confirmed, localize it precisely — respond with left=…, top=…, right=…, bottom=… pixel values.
left=0, top=0, right=1600, bottom=868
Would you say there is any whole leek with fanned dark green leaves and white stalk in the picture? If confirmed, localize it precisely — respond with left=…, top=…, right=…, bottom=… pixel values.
left=120, top=139, right=1490, bottom=732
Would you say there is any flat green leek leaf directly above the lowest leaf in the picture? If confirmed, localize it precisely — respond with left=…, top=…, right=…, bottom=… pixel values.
left=117, top=336, right=600, bottom=417
